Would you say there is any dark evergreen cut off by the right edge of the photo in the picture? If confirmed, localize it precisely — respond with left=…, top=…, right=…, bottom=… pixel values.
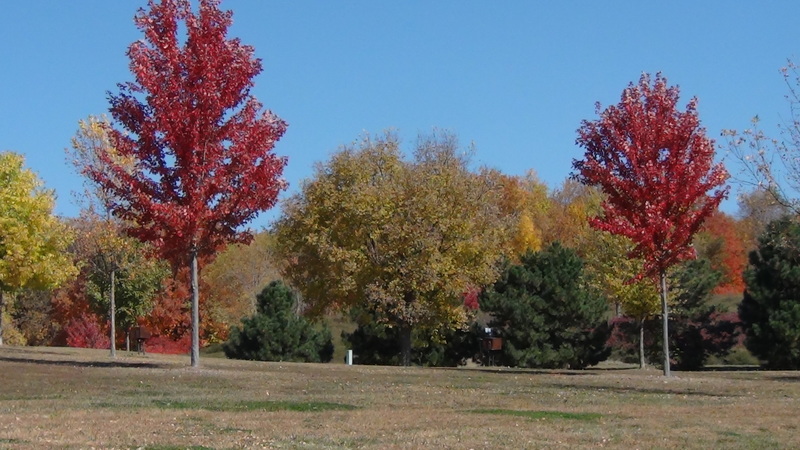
left=739, top=217, right=800, bottom=369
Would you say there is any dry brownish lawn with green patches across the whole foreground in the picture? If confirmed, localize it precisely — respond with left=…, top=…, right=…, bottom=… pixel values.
left=0, top=347, right=800, bottom=449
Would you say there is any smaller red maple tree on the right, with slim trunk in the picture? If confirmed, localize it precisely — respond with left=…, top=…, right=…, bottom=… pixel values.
left=573, top=74, right=728, bottom=375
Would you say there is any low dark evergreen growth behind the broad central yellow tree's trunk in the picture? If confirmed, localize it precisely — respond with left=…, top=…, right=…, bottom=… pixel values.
left=342, top=306, right=479, bottom=367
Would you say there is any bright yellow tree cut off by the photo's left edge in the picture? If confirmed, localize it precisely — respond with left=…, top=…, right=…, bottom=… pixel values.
left=0, top=152, right=76, bottom=345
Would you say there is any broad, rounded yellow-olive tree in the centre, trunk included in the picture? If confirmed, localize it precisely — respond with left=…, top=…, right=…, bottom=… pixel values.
left=276, top=133, right=507, bottom=365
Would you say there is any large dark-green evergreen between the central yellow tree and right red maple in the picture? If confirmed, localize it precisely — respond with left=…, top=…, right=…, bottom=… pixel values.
left=480, top=243, right=610, bottom=368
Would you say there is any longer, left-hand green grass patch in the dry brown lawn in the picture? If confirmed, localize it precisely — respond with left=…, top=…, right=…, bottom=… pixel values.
left=146, top=400, right=358, bottom=412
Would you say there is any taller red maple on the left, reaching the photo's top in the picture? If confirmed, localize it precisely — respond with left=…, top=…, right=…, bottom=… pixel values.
left=84, top=0, right=286, bottom=366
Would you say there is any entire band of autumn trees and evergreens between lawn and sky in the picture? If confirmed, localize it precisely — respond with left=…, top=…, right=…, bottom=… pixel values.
left=0, top=0, right=800, bottom=375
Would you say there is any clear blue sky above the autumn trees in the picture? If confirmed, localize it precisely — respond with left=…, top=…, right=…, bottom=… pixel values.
left=0, top=0, right=800, bottom=226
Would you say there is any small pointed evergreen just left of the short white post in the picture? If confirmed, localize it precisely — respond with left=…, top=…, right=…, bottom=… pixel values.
left=222, top=281, right=333, bottom=362
